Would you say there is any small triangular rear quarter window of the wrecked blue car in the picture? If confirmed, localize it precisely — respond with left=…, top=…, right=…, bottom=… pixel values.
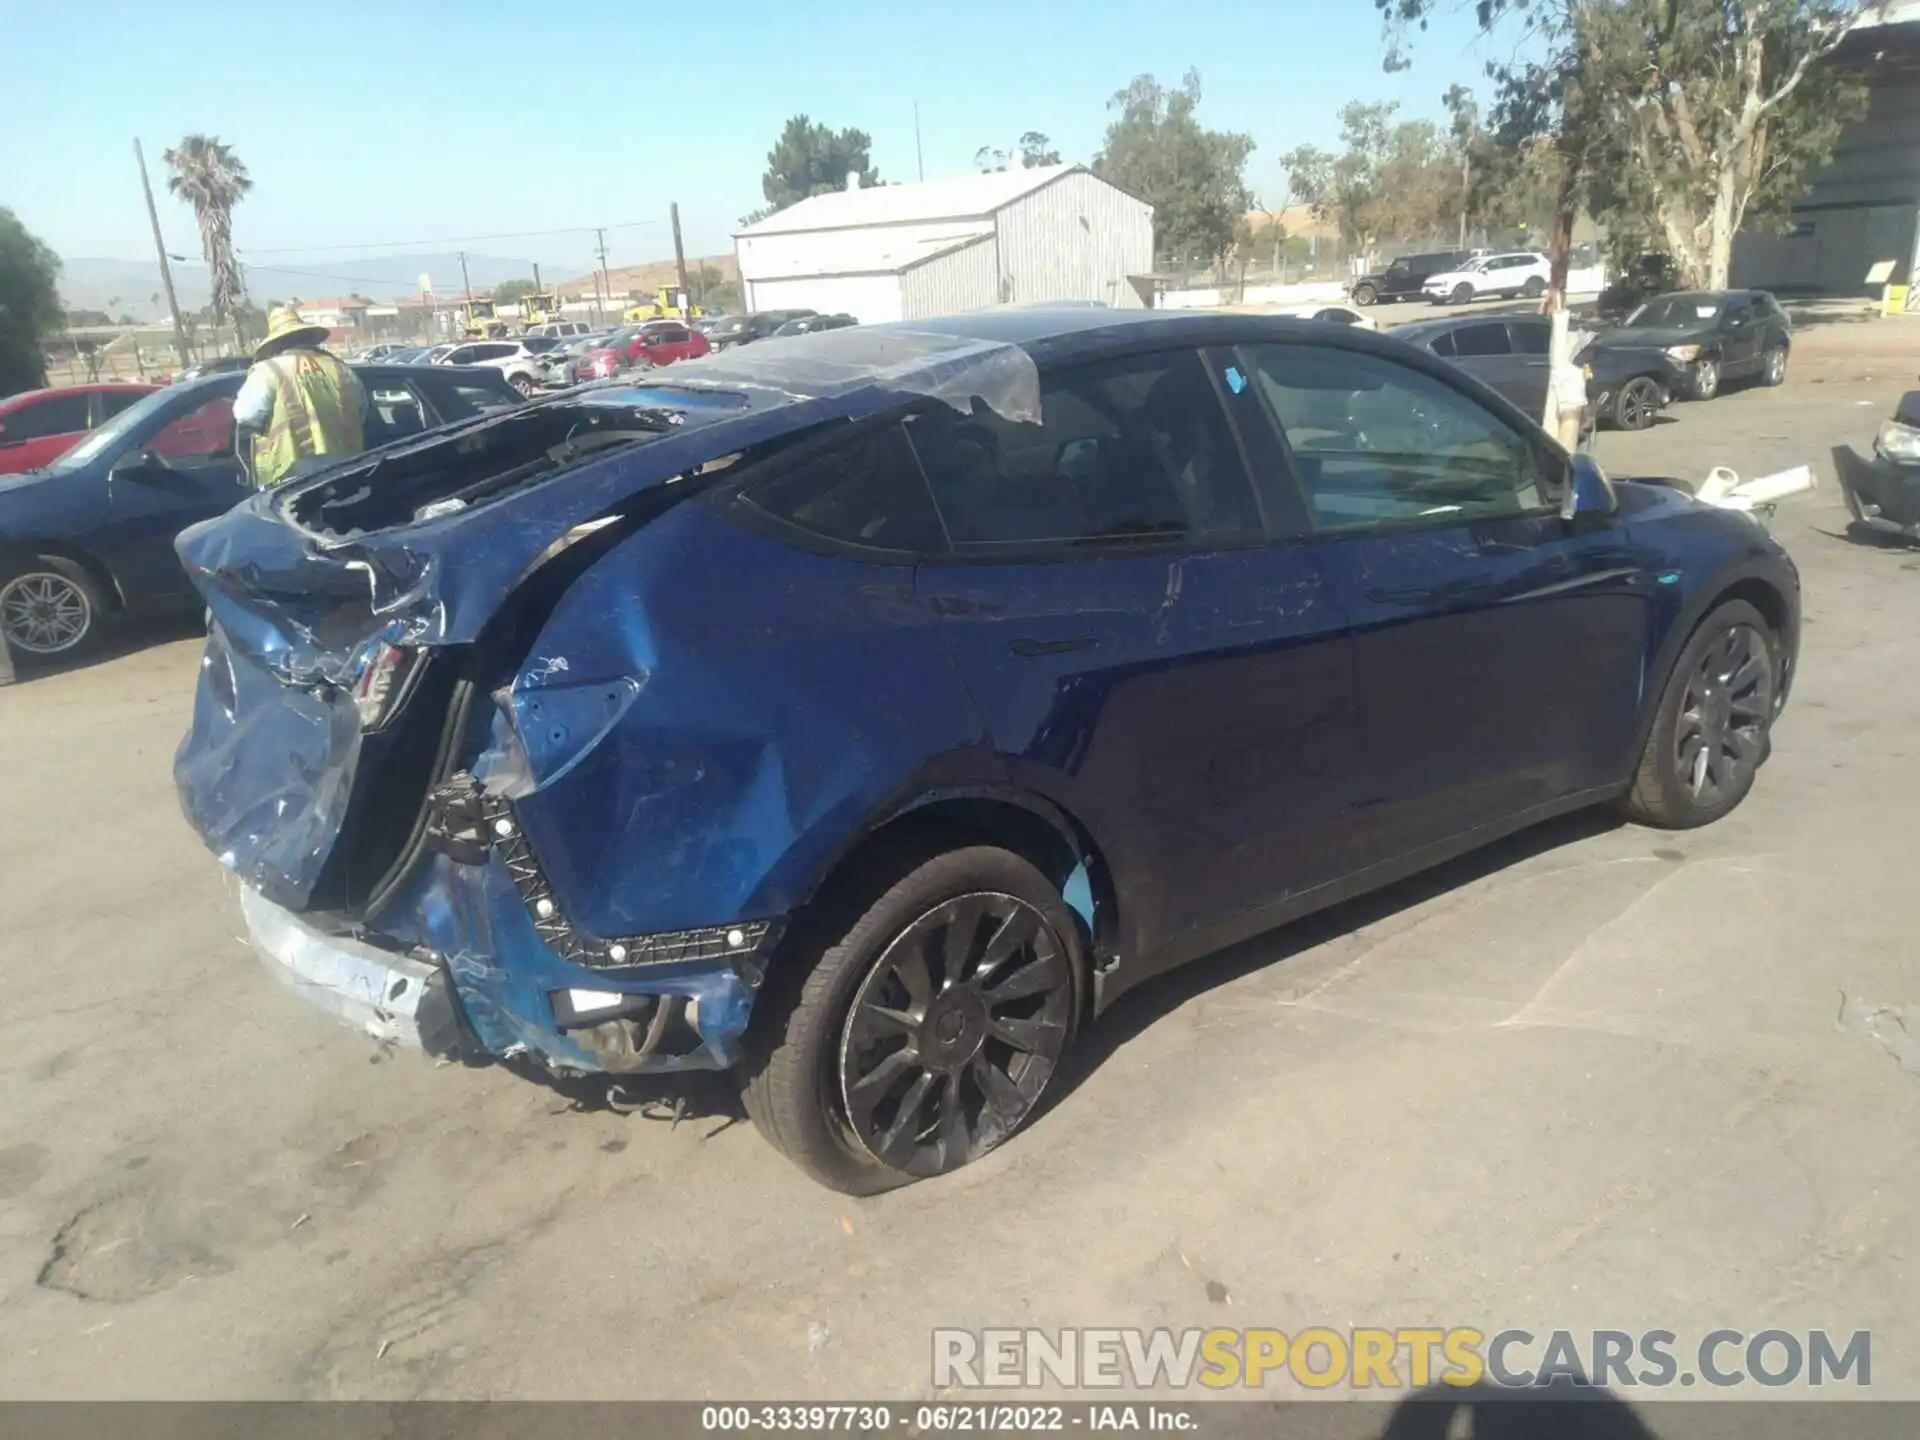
left=741, top=424, right=947, bottom=555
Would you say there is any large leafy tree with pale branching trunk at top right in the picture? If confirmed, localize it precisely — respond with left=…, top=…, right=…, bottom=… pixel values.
left=1375, top=0, right=1880, bottom=288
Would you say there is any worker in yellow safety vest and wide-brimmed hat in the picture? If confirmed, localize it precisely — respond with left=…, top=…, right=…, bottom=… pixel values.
left=234, top=305, right=367, bottom=486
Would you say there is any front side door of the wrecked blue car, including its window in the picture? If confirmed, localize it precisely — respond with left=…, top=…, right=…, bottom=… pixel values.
left=1246, top=344, right=1651, bottom=860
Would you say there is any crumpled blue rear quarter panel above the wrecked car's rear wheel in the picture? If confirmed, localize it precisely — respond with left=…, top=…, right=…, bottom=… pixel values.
left=515, top=499, right=1000, bottom=948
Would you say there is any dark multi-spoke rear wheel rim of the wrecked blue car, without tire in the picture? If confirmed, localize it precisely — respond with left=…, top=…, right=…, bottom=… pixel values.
left=839, top=895, right=1073, bottom=1175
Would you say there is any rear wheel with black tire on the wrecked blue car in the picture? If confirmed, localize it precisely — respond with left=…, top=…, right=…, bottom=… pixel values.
left=741, top=845, right=1087, bottom=1194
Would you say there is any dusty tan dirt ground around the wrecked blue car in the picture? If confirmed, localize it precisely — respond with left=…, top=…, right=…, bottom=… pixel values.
left=0, top=321, right=1920, bottom=1398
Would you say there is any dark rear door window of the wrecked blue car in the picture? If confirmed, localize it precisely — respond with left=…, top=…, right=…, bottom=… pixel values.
left=908, top=349, right=1261, bottom=555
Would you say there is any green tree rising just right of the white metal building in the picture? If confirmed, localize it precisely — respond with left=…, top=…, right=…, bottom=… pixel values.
left=1092, top=71, right=1254, bottom=265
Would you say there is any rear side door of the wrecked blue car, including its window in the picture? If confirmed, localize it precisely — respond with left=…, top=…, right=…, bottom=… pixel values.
left=910, top=349, right=1357, bottom=952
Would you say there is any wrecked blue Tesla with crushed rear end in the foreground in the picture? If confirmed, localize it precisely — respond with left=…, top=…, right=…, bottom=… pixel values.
left=175, top=309, right=1799, bottom=1192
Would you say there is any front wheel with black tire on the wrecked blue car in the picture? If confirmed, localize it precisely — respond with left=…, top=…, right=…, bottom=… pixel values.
left=1624, top=601, right=1780, bottom=829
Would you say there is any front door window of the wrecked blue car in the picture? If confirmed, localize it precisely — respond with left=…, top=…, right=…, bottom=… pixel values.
left=1248, top=346, right=1563, bottom=532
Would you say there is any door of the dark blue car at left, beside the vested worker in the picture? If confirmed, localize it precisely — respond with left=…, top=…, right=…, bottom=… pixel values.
left=96, top=376, right=248, bottom=607
